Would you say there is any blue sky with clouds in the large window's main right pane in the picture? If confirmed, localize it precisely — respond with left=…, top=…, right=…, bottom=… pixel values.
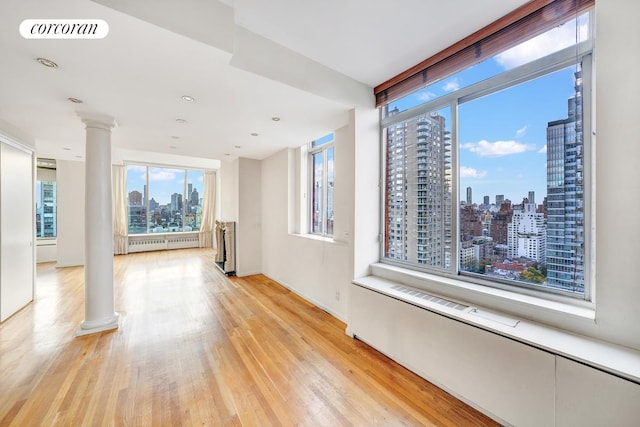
left=459, top=69, right=574, bottom=204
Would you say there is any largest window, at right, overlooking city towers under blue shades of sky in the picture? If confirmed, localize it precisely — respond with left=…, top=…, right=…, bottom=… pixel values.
left=382, top=12, right=593, bottom=299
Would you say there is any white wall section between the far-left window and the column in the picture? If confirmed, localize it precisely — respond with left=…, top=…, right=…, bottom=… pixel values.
left=56, top=160, right=85, bottom=267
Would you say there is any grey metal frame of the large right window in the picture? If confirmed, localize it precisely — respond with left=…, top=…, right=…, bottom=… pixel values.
left=379, top=37, right=595, bottom=306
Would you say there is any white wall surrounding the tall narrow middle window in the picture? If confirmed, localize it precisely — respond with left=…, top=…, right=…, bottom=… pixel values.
left=262, top=108, right=370, bottom=321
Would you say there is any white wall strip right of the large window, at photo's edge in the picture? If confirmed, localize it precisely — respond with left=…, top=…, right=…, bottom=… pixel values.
left=593, top=1, right=640, bottom=350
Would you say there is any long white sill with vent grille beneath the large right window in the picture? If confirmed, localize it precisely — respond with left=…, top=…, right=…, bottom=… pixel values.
left=353, top=272, right=640, bottom=384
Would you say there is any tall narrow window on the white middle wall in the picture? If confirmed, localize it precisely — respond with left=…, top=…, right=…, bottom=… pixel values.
left=309, top=133, right=334, bottom=236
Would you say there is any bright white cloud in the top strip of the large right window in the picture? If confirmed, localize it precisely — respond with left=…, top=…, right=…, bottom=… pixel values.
left=495, top=21, right=588, bottom=70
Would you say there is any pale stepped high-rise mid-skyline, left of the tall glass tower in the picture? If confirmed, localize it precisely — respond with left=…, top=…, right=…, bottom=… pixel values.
left=507, top=199, right=547, bottom=264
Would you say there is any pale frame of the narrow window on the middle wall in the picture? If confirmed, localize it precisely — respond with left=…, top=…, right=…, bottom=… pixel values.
left=307, top=132, right=335, bottom=238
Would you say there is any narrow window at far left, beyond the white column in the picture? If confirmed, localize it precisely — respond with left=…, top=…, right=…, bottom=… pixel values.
left=36, top=159, right=58, bottom=239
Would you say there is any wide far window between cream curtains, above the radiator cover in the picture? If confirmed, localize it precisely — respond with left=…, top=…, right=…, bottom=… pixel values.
left=127, top=164, right=203, bottom=234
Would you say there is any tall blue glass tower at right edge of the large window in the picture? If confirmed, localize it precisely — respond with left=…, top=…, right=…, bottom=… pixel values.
left=547, top=70, right=585, bottom=292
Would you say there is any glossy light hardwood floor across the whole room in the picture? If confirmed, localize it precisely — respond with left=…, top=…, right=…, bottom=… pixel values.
left=0, top=249, right=495, bottom=426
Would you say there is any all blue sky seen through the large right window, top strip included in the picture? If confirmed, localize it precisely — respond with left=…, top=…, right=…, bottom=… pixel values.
left=389, top=16, right=588, bottom=208
